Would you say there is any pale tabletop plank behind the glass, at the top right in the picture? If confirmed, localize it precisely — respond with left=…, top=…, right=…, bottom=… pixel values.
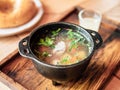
left=78, top=0, right=120, bottom=14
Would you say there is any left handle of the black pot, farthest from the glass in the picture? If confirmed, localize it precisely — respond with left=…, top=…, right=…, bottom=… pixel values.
left=18, top=37, right=32, bottom=59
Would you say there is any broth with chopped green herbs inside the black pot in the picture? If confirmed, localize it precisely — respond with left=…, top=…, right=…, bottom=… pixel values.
left=34, top=28, right=91, bottom=65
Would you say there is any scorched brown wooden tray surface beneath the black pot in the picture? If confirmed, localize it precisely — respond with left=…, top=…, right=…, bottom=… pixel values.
left=0, top=10, right=120, bottom=90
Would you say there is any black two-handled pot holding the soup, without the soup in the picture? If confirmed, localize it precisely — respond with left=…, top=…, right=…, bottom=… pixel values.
left=19, top=22, right=102, bottom=83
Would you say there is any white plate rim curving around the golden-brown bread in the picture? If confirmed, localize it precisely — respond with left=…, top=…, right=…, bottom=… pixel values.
left=0, top=0, right=43, bottom=37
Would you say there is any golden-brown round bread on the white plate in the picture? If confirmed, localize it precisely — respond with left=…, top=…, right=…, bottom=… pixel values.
left=0, top=0, right=37, bottom=28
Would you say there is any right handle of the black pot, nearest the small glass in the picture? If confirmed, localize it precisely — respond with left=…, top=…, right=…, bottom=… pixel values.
left=87, top=29, right=103, bottom=49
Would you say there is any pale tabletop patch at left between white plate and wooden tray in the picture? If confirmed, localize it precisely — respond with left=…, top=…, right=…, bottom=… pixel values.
left=0, top=36, right=19, bottom=65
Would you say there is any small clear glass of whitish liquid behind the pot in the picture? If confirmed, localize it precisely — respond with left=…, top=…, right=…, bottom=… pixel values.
left=78, top=9, right=102, bottom=32
